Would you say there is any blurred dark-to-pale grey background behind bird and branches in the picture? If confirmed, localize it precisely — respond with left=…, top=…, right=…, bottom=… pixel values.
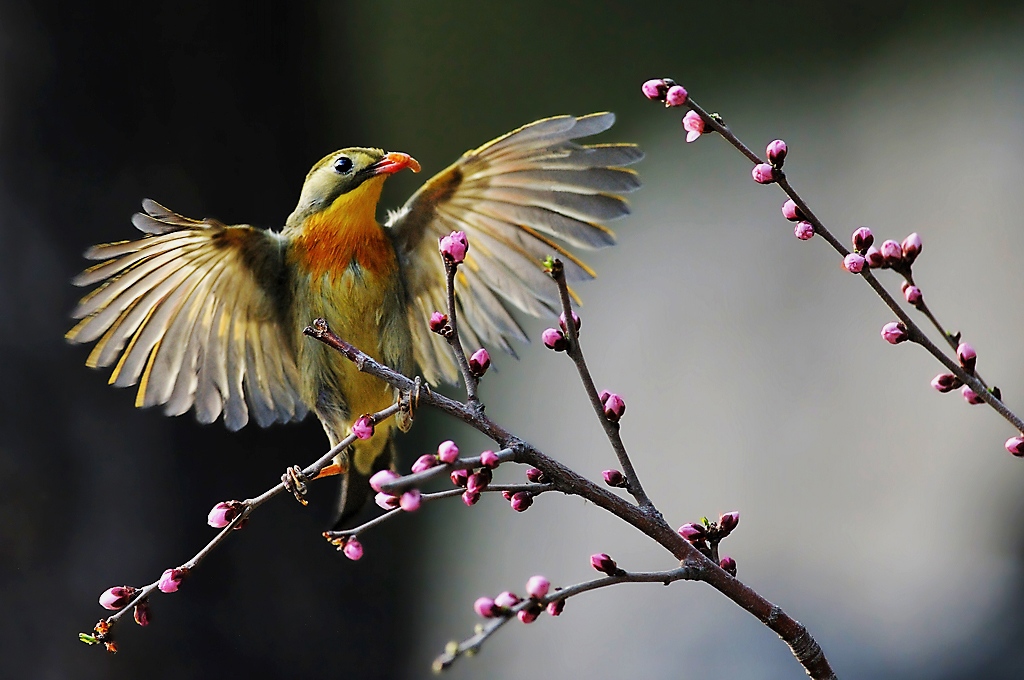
left=0, top=0, right=1024, bottom=679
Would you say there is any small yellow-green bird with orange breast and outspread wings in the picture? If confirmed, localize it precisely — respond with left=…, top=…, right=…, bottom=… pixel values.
left=66, top=113, right=643, bottom=526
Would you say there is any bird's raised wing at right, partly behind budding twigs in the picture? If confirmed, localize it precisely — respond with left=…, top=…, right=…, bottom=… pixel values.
left=388, top=113, right=643, bottom=382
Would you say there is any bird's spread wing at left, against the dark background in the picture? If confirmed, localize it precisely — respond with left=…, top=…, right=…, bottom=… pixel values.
left=67, top=201, right=306, bottom=430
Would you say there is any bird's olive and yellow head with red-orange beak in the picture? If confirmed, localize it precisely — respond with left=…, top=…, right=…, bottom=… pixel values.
left=287, top=146, right=420, bottom=226
